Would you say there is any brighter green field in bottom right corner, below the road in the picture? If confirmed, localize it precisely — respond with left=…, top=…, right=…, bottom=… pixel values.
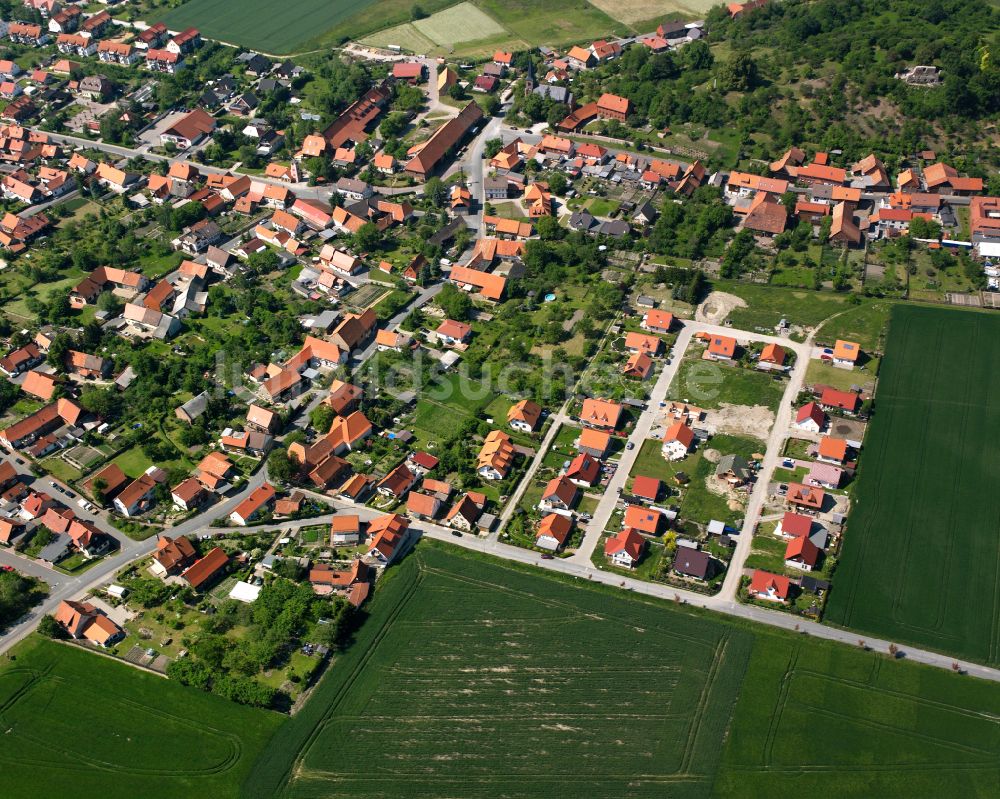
left=713, top=628, right=1000, bottom=799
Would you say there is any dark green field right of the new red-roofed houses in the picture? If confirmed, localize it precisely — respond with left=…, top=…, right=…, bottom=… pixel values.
left=827, top=305, right=1000, bottom=665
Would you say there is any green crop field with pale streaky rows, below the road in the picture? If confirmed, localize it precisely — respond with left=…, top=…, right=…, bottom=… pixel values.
left=245, top=544, right=750, bottom=799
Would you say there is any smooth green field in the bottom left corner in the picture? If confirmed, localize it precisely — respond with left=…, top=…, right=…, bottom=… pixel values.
left=0, top=636, right=281, bottom=799
